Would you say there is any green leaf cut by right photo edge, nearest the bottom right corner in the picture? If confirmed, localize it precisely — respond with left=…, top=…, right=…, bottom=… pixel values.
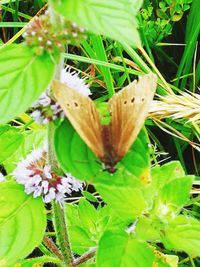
left=161, top=215, right=200, bottom=256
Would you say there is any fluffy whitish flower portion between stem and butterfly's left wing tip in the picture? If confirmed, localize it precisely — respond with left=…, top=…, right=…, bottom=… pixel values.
left=61, top=66, right=91, bottom=96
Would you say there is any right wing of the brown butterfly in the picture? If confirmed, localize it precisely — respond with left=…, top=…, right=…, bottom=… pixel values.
left=108, top=74, right=157, bottom=161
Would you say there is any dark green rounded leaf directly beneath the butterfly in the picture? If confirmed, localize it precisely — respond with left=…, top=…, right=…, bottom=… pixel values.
left=54, top=120, right=150, bottom=187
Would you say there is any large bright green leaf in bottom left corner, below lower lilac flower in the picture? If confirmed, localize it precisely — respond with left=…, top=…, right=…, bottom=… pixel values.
left=0, top=182, right=46, bottom=267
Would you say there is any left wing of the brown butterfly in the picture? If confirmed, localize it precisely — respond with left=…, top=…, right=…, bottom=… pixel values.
left=52, top=81, right=104, bottom=158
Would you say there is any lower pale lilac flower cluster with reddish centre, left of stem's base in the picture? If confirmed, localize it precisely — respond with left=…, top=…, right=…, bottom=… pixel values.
left=13, top=149, right=83, bottom=206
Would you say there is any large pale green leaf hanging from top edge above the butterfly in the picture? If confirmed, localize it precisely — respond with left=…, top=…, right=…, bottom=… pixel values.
left=51, top=0, right=142, bottom=46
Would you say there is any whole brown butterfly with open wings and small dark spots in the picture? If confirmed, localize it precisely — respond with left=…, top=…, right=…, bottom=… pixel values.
left=52, top=74, right=157, bottom=173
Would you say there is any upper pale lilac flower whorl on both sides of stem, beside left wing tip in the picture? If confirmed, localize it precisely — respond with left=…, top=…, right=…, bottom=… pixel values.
left=30, top=67, right=91, bottom=124
